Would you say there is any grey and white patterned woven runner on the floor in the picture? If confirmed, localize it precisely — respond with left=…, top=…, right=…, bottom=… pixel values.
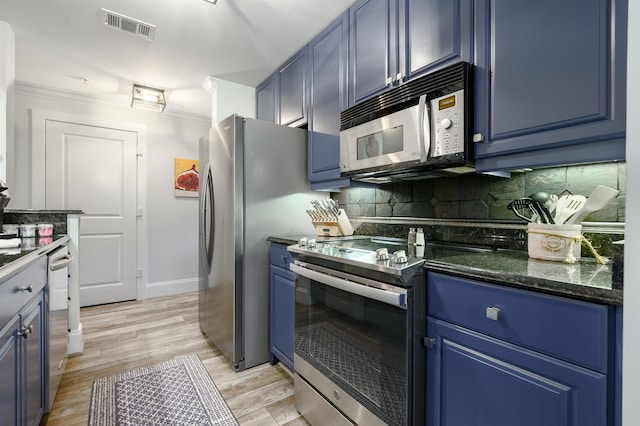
left=89, top=354, right=238, bottom=426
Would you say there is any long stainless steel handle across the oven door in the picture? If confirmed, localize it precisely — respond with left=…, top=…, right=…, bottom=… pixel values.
left=289, top=263, right=407, bottom=308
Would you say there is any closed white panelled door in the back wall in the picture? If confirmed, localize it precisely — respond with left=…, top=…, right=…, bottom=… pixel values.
left=45, top=120, right=138, bottom=306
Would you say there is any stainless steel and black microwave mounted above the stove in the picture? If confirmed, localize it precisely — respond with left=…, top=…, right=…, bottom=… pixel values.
left=340, top=62, right=475, bottom=183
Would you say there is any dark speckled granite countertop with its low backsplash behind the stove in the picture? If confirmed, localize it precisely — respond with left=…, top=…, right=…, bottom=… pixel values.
left=268, top=221, right=623, bottom=305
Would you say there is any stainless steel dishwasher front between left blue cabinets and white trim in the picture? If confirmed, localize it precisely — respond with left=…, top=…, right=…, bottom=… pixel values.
left=45, top=244, right=73, bottom=413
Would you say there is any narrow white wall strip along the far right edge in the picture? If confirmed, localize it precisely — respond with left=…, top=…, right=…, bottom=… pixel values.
left=622, top=1, right=640, bottom=426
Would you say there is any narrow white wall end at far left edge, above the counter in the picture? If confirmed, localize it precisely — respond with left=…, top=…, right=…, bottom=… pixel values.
left=0, top=21, right=15, bottom=180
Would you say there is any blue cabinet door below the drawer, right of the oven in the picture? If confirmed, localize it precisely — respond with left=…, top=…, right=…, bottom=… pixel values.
left=426, top=318, right=607, bottom=426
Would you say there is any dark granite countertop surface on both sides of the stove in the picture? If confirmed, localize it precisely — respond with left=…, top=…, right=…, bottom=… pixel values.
left=268, top=235, right=623, bottom=305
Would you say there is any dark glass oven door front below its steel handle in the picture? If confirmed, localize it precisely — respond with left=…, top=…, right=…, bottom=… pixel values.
left=295, top=262, right=410, bottom=425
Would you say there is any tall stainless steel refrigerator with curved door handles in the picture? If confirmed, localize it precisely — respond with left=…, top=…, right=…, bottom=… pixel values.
left=198, top=115, right=327, bottom=371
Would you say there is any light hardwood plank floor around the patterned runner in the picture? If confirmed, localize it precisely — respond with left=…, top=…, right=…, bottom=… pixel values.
left=43, top=293, right=308, bottom=426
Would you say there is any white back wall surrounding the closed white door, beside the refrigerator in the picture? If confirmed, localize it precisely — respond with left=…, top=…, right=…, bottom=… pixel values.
left=7, top=84, right=211, bottom=299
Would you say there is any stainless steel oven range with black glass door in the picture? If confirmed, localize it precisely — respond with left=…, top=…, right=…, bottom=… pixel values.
left=288, top=237, right=425, bottom=426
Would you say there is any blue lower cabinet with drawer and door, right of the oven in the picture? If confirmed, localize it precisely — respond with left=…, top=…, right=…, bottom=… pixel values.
left=425, top=272, right=620, bottom=426
